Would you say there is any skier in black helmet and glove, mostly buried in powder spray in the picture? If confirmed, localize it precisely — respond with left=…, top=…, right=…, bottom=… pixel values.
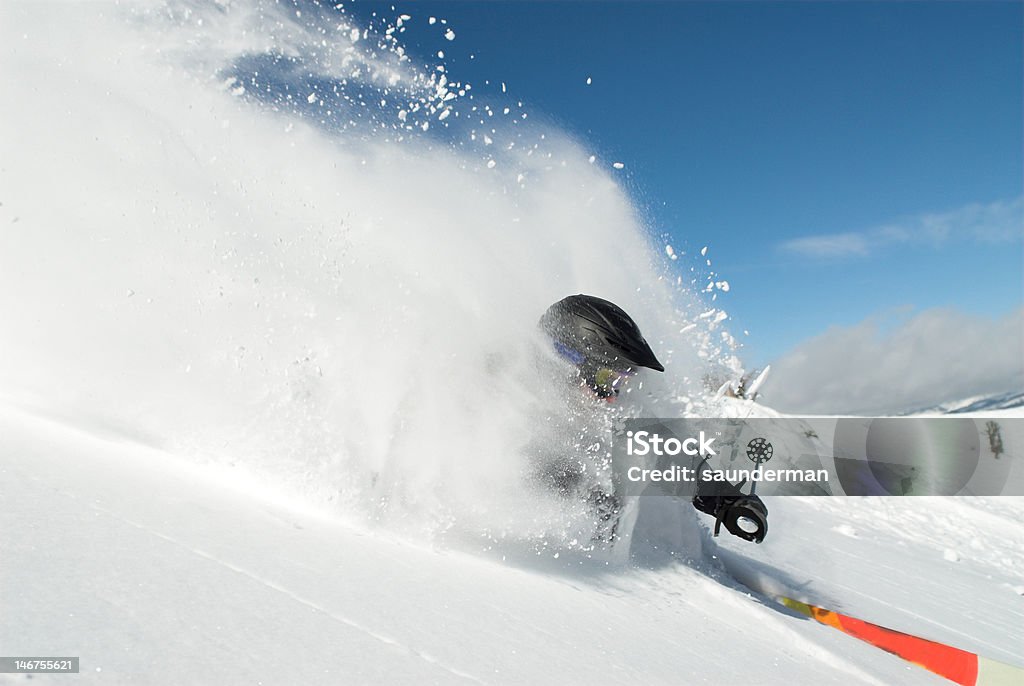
left=540, top=294, right=768, bottom=543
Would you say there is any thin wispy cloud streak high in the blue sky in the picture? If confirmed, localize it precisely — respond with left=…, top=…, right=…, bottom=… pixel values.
left=780, top=198, right=1024, bottom=258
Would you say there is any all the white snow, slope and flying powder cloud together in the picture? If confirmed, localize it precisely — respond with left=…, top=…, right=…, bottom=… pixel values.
left=0, top=2, right=1024, bottom=684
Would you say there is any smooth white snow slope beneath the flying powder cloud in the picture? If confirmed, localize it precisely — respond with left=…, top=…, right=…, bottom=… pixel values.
left=0, top=408, right=1007, bottom=684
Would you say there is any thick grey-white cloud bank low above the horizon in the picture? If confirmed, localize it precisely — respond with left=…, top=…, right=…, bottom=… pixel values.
left=764, top=309, right=1024, bottom=415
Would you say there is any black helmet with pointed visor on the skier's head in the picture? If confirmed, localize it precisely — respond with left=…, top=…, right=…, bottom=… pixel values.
left=541, top=295, right=665, bottom=372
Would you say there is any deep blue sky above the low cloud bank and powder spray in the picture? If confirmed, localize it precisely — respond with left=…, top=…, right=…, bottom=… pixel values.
left=350, top=1, right=1024, bottom=365
